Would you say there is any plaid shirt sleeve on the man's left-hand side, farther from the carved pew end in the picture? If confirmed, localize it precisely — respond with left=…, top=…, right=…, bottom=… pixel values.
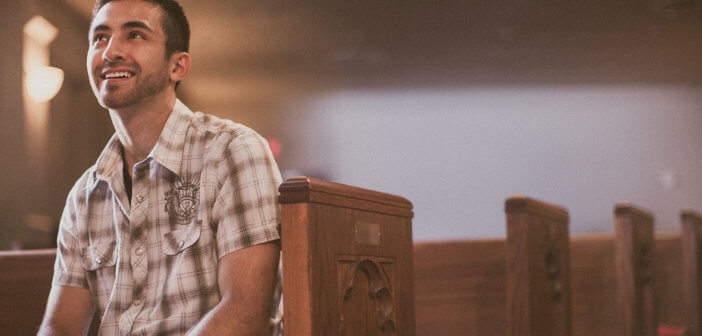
left=52, top=187, right=88, bottom=288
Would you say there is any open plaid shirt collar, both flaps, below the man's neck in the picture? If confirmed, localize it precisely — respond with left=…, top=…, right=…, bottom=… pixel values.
left=87, top=99, right=193, bottom=186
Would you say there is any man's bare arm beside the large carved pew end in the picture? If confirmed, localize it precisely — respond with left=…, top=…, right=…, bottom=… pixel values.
left=188, top=241, right=280, bottom=336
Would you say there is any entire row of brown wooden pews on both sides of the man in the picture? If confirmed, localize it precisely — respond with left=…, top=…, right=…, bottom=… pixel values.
left=0, top=177, right=702, bottom=336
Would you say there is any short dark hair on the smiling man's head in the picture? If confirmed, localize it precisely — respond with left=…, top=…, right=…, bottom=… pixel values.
left=93, top=0, right=190, bottom=58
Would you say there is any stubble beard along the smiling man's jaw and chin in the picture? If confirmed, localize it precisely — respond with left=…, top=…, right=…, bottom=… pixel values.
left=96, top=62, right=168, bottom=109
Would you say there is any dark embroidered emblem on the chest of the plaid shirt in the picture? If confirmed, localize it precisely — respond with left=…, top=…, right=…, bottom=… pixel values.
left=165, top=175, right=200, bottom=225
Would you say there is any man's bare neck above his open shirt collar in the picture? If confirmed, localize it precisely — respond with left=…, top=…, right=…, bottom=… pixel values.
left=109, top=90, right=176, bottom=176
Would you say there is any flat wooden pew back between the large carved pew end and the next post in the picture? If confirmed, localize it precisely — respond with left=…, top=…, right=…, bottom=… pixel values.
left=414, top=239, right=507, bottom=336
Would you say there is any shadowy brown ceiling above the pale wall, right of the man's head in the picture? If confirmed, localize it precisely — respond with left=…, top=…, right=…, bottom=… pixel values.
left=66, top=0, right=702, bottom=116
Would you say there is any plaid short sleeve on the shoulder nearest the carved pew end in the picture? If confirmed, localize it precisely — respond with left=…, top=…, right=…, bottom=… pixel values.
left=212, top=131, right=282, bottom=258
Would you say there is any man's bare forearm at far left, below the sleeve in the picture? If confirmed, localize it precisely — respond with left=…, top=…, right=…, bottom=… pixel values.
left=37, top=286, right=95, bottom=336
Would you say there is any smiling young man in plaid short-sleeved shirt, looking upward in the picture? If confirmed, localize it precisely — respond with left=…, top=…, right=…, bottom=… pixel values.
left=39, top=0, right=281, bottom=335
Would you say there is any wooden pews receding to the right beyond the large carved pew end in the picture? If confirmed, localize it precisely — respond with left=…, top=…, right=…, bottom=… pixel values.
left=414, top=196, right=702, bottom=336
